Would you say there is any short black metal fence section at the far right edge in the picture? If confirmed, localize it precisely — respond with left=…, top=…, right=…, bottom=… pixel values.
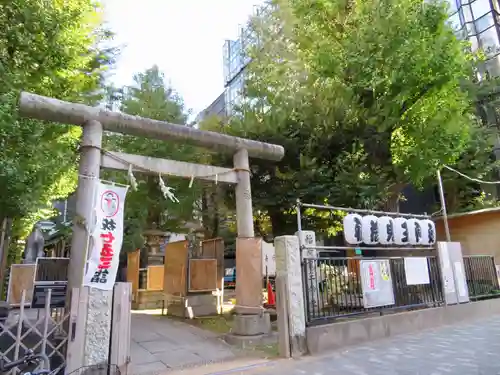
left=464, top=255, right=500, bottom=301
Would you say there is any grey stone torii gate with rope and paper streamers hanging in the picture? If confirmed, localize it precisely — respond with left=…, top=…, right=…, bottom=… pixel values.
left=19, top=92, right=285, bottom=365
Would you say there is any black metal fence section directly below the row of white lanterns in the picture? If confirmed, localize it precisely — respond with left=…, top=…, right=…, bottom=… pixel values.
left=302, top=257, right=444, bottom=325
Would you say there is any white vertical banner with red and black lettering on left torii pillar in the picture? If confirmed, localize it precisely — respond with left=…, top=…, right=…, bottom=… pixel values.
left=83, top=181, right=128, bottom=290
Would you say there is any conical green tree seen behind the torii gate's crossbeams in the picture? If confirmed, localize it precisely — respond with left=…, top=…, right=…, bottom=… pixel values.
left=104, top=66, right=201, bottom=251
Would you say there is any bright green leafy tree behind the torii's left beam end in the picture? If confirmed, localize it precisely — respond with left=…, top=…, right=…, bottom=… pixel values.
left=0, top=0, right=115, bottom=244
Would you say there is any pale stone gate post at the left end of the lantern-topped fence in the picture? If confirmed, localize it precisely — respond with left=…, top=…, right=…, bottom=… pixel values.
left=274, top=236, right=307, bottom=357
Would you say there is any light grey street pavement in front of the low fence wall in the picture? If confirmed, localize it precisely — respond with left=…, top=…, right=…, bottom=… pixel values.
left=247, top=316, right=500, bottom=375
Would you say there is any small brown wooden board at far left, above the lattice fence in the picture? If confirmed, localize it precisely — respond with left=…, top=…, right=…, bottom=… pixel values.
left=7, top=264, right=36, bottom=306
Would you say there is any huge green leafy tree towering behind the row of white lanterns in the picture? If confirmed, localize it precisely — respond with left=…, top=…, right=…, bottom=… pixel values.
left=203, top=0, right=484, bottom=235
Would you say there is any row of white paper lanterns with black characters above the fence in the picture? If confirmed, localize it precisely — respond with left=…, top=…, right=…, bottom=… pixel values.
left=343, top=214, right=436, bottom=246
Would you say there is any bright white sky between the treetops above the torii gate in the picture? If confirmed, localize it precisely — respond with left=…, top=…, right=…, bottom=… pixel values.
left=102, top=0, right=263, bottom=114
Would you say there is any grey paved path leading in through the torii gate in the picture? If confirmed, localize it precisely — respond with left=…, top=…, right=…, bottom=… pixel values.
left=129, top=312, right=246, bottom=375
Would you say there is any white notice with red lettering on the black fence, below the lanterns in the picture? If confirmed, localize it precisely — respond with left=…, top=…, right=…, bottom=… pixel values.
left=359, top=259, right=395, bottom=308
